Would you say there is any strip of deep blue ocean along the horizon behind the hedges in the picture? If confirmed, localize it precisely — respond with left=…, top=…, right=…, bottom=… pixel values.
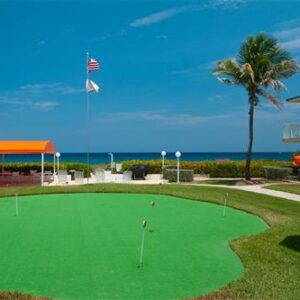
left=0, top=152, right=292, bottom=165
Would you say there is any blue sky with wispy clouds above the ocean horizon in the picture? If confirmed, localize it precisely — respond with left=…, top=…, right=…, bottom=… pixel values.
left=0, top=0, right=300, bottom=152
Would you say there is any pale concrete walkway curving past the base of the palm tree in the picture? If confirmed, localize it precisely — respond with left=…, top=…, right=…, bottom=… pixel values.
left=197, top=184, right=300, bottom=202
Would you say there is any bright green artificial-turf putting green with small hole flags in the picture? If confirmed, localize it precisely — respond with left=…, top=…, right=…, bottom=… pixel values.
left=0, top=193, right=267, bottom=299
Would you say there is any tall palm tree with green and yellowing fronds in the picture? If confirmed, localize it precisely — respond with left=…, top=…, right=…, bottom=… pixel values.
left=214, top=33, right=299, bottom=180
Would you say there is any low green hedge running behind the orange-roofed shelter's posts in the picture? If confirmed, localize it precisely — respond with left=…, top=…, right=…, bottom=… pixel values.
left=0, top=162, right=92, bottom=177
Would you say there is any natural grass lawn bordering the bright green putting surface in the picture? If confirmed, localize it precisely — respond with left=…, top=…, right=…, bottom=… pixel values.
left=0, top=184, right=300, bottom=299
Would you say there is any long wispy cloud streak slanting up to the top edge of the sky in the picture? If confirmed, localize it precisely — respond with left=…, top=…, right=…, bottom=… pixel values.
left=130, top=0, right=243, bottom=27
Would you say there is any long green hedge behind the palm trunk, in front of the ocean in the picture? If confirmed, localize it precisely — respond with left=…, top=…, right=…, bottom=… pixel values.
left=122, top=160, right=291, bottom=178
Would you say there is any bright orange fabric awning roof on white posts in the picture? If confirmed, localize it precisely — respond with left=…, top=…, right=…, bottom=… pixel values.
left=0, top=141, right=55, bottom=154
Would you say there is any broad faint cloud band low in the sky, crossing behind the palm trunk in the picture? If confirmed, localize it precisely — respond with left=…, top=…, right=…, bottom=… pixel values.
left=96, top=101, right=299, bottom=128
